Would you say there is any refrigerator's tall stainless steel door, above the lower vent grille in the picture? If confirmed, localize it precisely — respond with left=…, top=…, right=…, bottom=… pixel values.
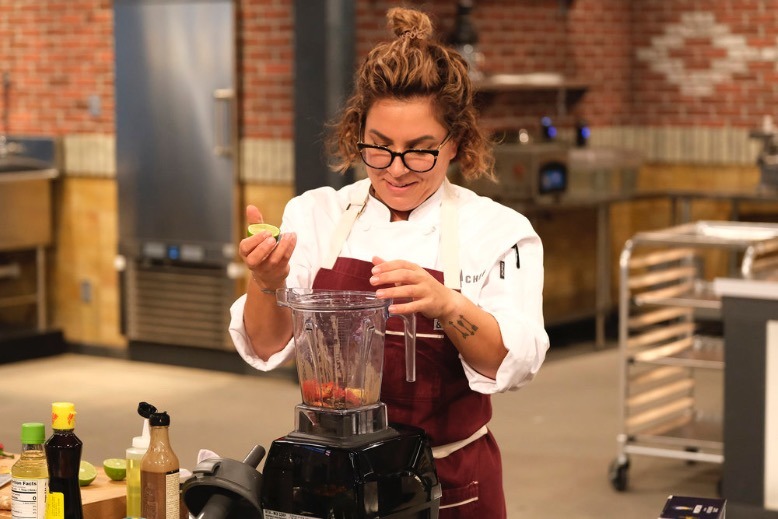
left=114, top=0, right=236, bottom=264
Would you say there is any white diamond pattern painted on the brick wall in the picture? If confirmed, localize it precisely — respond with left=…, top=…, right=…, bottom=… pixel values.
left=636, top=11, right=778, bottom=97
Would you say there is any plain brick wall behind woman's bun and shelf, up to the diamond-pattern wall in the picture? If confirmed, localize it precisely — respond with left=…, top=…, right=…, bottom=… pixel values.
left=357, top=0, right=630, bottom=130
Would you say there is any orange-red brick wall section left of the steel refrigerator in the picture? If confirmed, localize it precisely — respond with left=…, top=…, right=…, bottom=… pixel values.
left=0, top=0, right=114, bottom=135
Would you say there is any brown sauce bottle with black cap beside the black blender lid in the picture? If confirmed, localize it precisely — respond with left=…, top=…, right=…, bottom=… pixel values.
left=140, top=411, right=180, bottom=519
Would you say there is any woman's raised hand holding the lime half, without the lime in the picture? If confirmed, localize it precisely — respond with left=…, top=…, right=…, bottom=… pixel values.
left=238, top=205, right=297, bottom=290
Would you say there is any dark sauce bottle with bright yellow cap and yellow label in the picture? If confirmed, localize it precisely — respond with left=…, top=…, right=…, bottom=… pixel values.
left=44, top=402, right=84, bottom=519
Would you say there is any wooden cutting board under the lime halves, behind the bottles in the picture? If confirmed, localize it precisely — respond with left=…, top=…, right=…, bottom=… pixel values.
left=0, top=456, right=127, bottom=519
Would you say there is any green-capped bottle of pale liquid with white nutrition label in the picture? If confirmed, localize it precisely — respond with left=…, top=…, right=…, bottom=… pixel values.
left=11, top=422, right=49, bottom=519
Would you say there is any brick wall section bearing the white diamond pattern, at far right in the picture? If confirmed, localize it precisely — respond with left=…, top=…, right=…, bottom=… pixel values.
left=630, top=0, right=778, bottom=127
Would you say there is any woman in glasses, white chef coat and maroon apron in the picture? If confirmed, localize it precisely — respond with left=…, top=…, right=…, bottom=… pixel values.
left=230, top=8, right=548, bottom=518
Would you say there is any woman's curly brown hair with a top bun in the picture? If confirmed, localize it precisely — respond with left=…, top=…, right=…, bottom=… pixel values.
left=328, top=7, right=494, bottom=180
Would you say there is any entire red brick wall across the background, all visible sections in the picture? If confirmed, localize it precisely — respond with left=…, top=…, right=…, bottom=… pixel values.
left=0, top=0, right=778, bottom=139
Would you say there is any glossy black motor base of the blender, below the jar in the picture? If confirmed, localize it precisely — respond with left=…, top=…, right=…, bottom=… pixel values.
left=261, top=424, right=441, bottom=519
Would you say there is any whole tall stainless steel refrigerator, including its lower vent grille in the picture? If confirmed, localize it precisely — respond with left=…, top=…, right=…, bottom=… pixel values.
left=114, top=0, right=239, bottom=352
